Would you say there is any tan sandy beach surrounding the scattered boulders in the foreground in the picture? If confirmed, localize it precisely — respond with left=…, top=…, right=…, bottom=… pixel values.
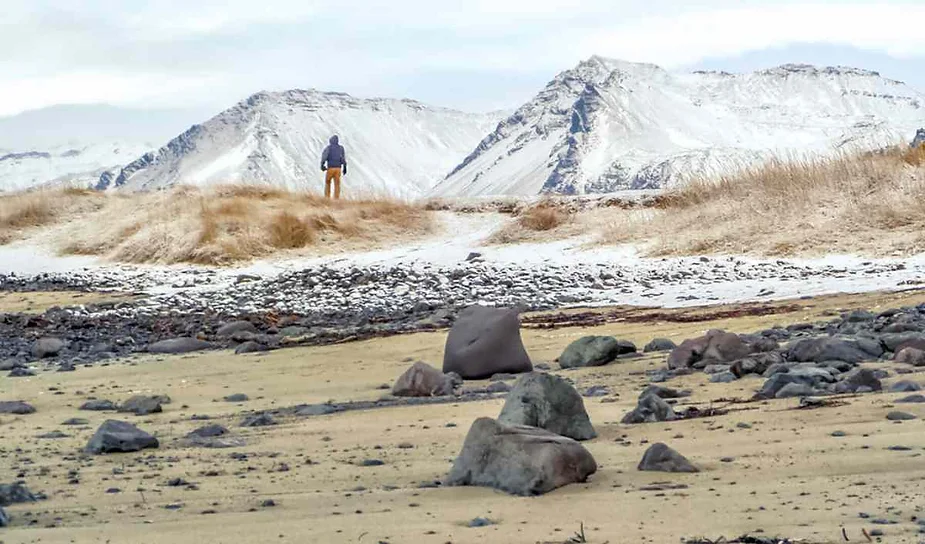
left=0, top=291, right=925, bottom=544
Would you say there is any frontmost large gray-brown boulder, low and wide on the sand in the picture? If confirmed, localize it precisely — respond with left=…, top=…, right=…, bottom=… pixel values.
left=446, top=417, right=597, bottom=496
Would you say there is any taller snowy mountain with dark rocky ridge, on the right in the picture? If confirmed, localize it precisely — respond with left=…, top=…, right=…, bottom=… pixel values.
left=432, top=57, right=925, bottom=196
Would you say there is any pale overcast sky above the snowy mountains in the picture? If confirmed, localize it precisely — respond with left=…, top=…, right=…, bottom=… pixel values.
left=0, top=0, right=925, bottom=115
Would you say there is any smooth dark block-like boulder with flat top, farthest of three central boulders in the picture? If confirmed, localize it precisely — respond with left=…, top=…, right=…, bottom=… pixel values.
left=443, top=306, right=533, bottom=380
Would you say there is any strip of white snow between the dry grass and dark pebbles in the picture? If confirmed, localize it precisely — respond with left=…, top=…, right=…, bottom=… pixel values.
left=0, top=212, right=925, bottom=307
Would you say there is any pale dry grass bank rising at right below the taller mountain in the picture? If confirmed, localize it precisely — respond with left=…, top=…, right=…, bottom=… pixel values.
left=603, top=148, right=925, bottom=256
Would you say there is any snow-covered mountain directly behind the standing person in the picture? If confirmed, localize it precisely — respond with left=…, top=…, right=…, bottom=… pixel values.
left=108, top=90, right=503, bottom=198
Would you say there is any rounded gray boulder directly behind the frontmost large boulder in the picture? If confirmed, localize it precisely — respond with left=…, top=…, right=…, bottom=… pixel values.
left=498, top=372, right=597, bottom=440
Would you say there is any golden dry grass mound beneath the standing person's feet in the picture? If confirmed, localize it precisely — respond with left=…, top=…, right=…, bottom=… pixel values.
left=0, top=186, right=432, bottom=265
